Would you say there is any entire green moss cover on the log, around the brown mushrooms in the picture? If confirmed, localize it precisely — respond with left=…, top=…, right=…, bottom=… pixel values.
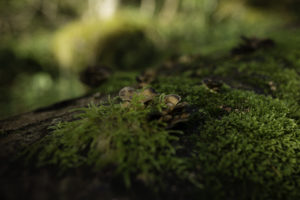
left=23, top=32, right=300, bottom=200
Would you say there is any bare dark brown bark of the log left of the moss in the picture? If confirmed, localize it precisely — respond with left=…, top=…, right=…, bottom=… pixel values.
left=0, top=93, right=119, bottom=200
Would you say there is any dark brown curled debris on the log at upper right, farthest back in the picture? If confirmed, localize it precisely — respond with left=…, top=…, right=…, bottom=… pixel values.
left=231, top=36, right=275, bottom=55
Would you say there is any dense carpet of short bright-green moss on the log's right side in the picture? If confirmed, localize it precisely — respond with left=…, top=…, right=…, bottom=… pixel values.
left=157, top=81, right=300, bottom=199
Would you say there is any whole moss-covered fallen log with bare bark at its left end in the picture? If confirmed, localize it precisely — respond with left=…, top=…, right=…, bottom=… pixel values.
left=0, top=33, right=300, bottom=200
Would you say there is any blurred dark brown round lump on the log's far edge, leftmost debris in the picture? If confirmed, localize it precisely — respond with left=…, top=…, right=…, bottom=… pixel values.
left=80, top=65, right=111, bottom=88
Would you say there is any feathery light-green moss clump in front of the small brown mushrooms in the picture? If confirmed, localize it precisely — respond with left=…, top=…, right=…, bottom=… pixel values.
left=25, top=93, right=190, bottom=186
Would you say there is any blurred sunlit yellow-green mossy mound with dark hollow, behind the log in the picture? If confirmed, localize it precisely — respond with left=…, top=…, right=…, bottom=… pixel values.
left=53, top=15, right=157, bottom=71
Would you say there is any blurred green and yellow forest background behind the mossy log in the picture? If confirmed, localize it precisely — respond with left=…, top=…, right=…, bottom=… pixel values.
left=0, top=0, right=300, bottom=119
